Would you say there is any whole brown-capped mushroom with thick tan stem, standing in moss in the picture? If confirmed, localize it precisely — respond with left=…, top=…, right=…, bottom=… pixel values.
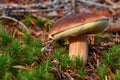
left=48, top=13, right=108, bottom=63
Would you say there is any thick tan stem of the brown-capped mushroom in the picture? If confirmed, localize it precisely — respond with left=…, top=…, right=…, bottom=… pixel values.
left=69, top=35, right=88, bottom=63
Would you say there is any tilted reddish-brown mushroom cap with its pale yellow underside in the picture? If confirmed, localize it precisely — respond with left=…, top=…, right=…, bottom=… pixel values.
left=48, top=13, right=108, bottom=40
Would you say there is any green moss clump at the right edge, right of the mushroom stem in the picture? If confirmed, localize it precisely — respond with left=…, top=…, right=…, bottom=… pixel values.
left=104, top=45, right=120, bottom=70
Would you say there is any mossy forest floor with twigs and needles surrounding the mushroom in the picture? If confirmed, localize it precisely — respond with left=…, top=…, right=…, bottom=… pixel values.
left=0, top=0, right=120, bottom=80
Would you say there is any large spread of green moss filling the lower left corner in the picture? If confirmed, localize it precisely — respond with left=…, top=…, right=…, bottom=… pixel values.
left=0, top=19, right=59, bottom=80
